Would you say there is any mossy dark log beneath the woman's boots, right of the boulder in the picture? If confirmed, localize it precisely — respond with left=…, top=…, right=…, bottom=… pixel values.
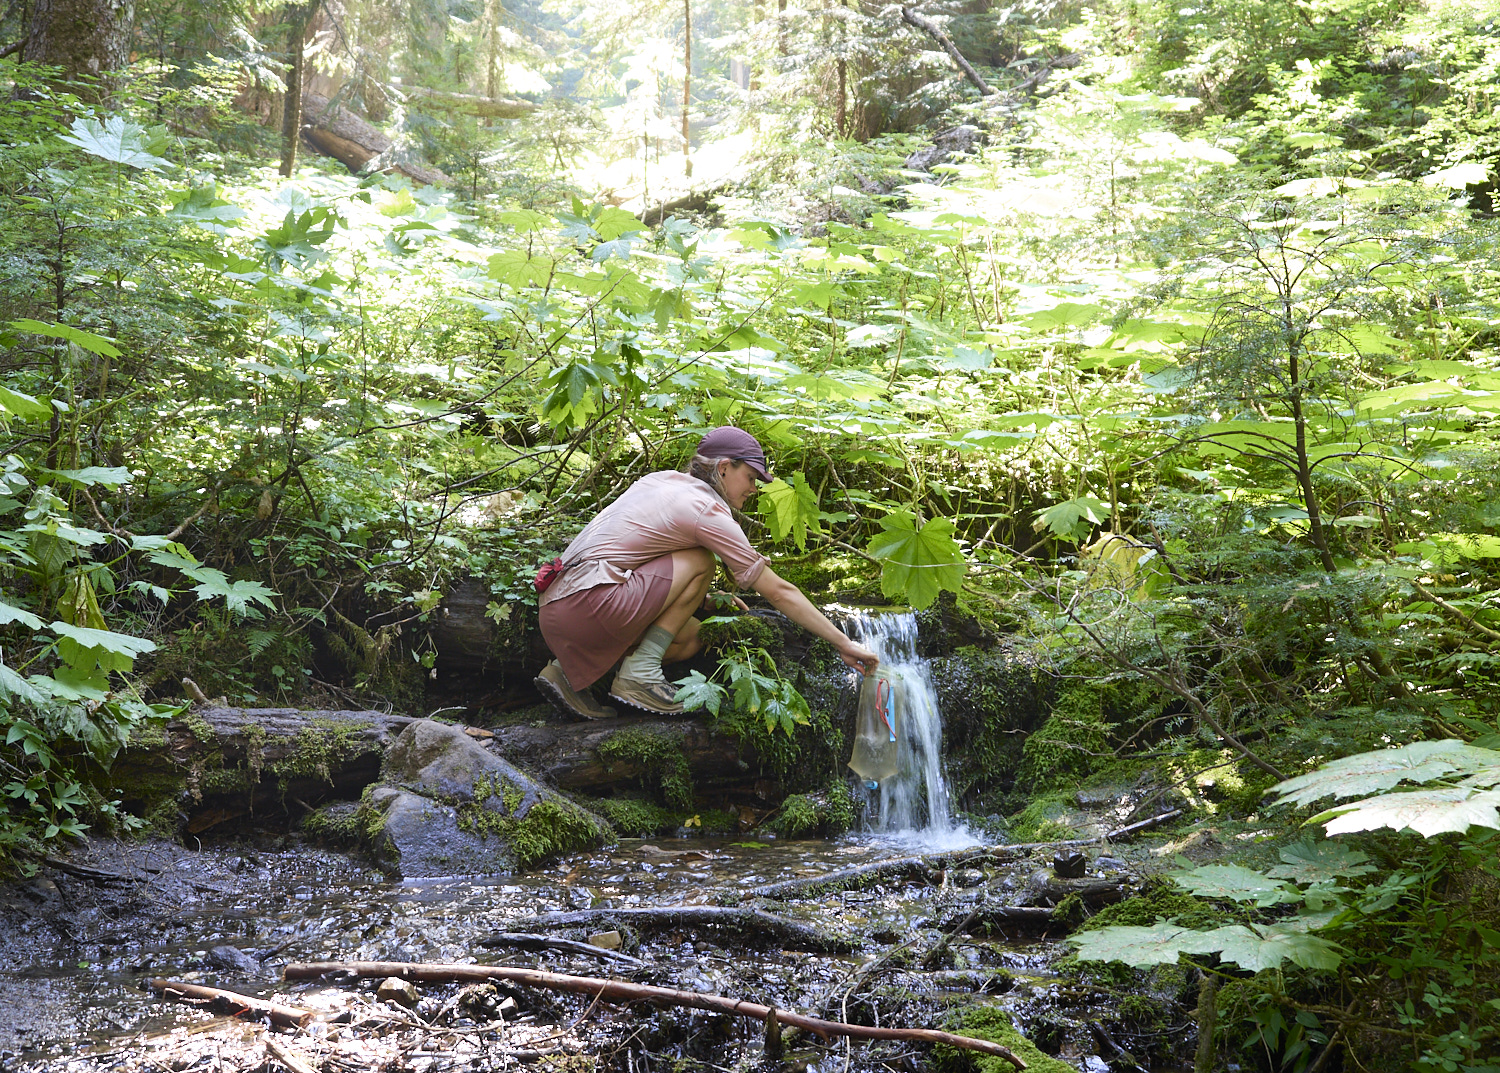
left=494, top=716, right=759, bottom=797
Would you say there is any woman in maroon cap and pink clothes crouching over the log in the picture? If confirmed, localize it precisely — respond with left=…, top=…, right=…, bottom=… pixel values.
left=536, top=426, right=879, bottom=719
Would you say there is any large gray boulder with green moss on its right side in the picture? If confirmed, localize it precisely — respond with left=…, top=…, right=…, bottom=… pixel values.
left=359, top=719, right=614, bottom=878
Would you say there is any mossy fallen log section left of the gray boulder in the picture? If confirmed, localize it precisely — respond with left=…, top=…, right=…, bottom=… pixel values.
left=110, top=707, right=413, bottom=834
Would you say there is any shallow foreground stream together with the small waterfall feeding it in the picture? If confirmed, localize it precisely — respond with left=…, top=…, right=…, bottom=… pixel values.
left=0, top=615, right=1167, bottom=1073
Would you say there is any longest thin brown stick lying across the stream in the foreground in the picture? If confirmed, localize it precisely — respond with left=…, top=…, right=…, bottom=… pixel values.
left=284, top=962, right=1026, bottom=1068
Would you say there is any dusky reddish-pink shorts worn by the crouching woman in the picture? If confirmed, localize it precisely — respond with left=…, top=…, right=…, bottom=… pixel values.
left=540, top=555, right=672, bottom=690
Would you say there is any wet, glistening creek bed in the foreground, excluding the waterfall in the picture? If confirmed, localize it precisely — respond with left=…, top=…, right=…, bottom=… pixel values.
left=0, top=836, right=1146, bottom=1073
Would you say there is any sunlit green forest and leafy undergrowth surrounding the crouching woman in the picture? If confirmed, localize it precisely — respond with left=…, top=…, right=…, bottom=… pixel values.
left=0, top=0, right=1500, bottom=1073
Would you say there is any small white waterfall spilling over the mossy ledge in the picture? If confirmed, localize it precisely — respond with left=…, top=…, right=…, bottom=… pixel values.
left=849, top=611, right=977, bottom=849
